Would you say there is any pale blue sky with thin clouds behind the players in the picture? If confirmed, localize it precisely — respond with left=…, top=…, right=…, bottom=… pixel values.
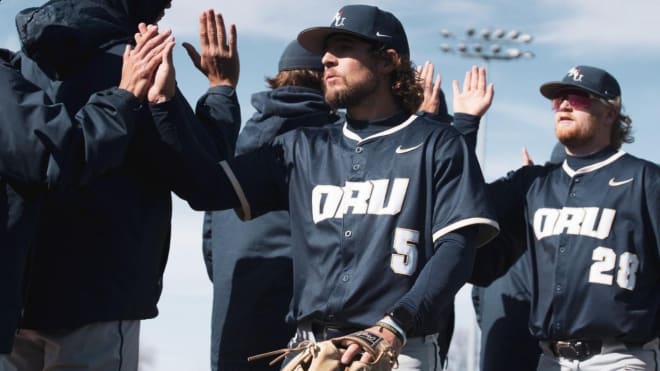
left=0, top=0, right=660, bottom=371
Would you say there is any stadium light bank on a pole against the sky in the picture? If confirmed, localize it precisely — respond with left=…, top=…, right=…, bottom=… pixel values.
left=440, top=28, right=534, bottom=172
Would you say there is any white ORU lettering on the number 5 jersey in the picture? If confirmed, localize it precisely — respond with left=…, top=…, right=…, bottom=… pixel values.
left=312, top=178, right=410, bottom=224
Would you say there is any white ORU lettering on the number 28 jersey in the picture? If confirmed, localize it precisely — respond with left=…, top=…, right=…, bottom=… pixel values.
left=534, top=207, right=616, bottom=240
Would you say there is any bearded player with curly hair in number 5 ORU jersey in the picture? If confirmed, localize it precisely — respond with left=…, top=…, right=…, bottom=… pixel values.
left=154, top=5, right=498, bottom=370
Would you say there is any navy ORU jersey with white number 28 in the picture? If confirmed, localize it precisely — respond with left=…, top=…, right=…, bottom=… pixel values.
left=484, top=148, right=660, bottom=342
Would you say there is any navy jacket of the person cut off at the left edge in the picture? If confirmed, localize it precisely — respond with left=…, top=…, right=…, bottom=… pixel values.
left=0, top=49, right=139, bottom=353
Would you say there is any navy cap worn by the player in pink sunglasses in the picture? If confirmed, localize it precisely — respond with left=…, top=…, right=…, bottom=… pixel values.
left=541, top=66, right=621, bottom=100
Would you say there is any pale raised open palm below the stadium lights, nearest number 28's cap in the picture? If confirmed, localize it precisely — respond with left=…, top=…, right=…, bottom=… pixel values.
left=452, top=66, right=494, bottom=116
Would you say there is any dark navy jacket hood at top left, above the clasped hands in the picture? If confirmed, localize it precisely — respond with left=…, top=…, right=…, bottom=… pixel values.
left=16, top=0, right=170, bottom=75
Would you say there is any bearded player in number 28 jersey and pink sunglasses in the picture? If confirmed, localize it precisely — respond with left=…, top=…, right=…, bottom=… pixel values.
left=473, top=66, right=660, bottom=371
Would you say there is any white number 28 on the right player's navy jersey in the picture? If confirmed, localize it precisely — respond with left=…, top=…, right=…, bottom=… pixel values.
left=589, top=247, right=639, bottom=290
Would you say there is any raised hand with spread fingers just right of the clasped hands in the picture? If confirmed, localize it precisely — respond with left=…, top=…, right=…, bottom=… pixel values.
left=183, top=10, right=240, bottom=87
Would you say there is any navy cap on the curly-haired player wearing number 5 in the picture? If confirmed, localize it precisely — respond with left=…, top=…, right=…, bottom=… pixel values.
left=298, top=5, right=410, bottom=55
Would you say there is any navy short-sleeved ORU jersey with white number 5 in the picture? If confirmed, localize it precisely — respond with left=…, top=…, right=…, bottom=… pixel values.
left=221, top=114, right=498, bottom=333
